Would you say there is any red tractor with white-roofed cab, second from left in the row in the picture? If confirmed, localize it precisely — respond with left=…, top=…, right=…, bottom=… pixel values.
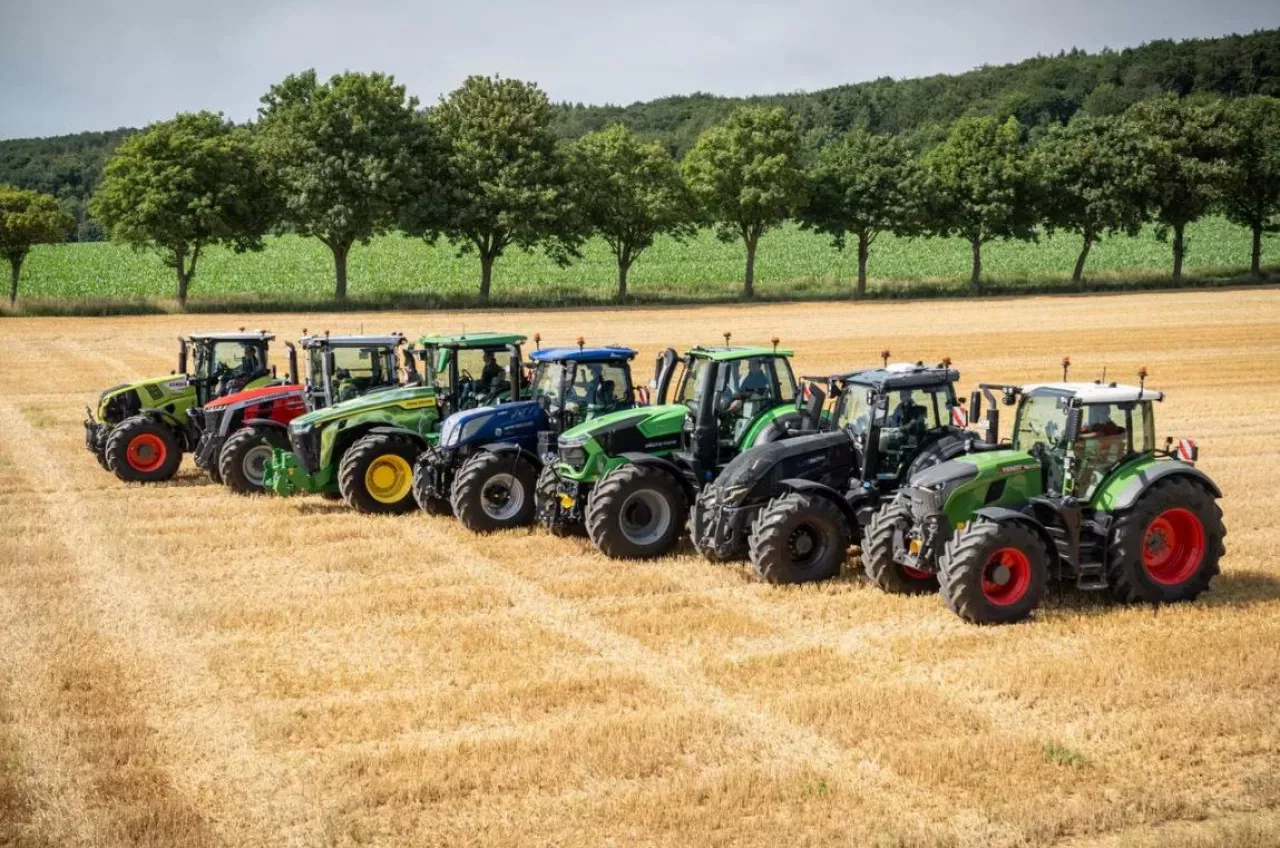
left=191, top=330, right=416, bottom=494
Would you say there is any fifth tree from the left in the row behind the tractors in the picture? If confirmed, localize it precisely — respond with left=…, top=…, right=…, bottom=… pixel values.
left=570, top=124, right=694, bottom=301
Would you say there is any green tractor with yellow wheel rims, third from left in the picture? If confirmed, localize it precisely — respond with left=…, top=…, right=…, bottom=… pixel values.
left=264, top=333, right=525, bottom=512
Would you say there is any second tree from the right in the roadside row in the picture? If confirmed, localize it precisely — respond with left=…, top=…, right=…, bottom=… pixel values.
left=1126, top=95, right=1228, bottom=281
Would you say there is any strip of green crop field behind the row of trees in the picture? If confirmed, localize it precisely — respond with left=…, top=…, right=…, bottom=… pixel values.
left=12, top=219, right=1280, bottom=310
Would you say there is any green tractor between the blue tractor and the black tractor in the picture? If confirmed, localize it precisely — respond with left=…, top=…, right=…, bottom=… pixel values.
left=538, top=333, right=805, bottom=559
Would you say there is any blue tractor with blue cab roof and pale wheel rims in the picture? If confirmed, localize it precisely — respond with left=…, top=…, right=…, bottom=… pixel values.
left=413, top=337, right=648, bottom=533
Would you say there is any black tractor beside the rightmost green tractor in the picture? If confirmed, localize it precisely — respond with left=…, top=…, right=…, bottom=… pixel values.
left=690, top=351, right=974, bottom=583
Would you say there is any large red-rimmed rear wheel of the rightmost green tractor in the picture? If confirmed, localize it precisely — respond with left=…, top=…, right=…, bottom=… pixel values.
left=1107, top=478, right=1226, bottom=612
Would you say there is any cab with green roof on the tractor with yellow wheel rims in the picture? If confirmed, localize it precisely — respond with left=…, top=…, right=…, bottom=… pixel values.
left=419, top=333, right=526, bottom=416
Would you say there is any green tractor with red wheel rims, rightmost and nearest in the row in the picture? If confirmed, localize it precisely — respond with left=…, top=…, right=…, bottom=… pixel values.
left=863, top=360, right=1226, bottom=624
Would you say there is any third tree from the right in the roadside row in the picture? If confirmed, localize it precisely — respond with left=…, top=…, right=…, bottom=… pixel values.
left=1032, top=117, right=1147, bottom=283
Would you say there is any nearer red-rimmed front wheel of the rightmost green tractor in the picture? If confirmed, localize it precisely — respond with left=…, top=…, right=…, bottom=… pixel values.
left=938, top=519, right=1048, bottom=624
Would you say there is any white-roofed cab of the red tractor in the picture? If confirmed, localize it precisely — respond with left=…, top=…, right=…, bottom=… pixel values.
left=291, top=333, right=417, bottom=409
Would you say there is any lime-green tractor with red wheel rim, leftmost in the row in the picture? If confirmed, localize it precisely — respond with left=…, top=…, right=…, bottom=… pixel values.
left=84, top=328, right=278, bottom=483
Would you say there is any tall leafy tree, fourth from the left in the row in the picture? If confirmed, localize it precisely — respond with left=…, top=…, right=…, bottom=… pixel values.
left=419, top=77, right=579, bottom=300
